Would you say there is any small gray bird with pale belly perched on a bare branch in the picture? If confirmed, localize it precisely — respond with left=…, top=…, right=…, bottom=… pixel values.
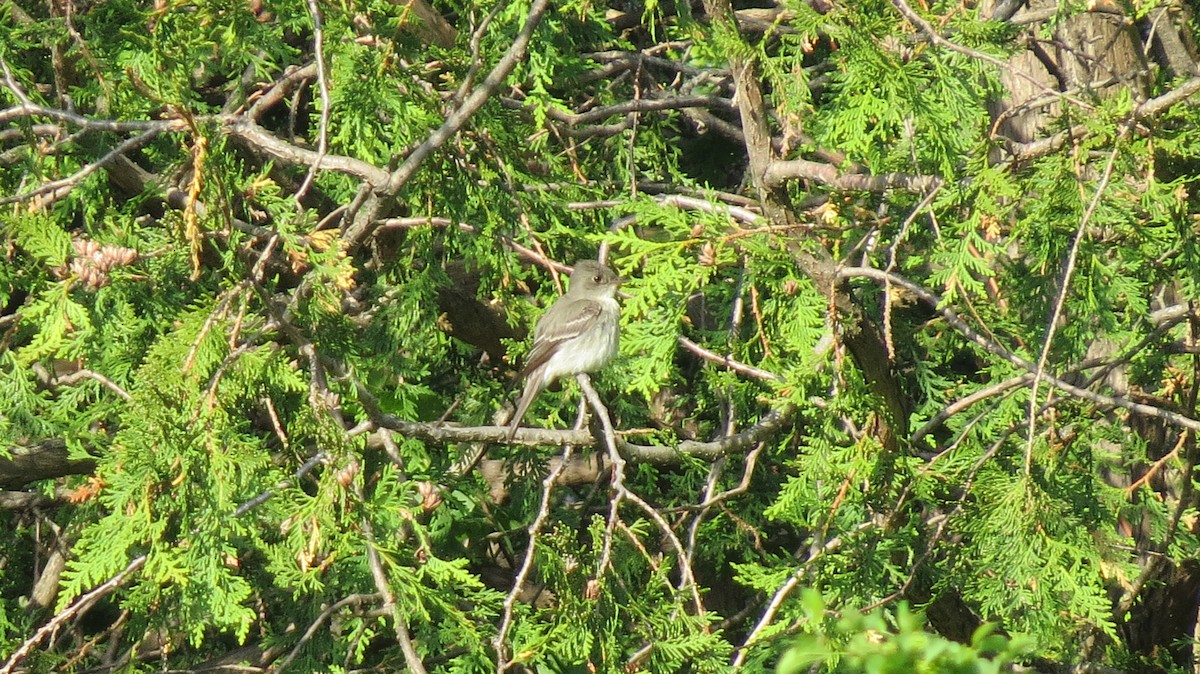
left=509, top=260, right=624, bottom=441
